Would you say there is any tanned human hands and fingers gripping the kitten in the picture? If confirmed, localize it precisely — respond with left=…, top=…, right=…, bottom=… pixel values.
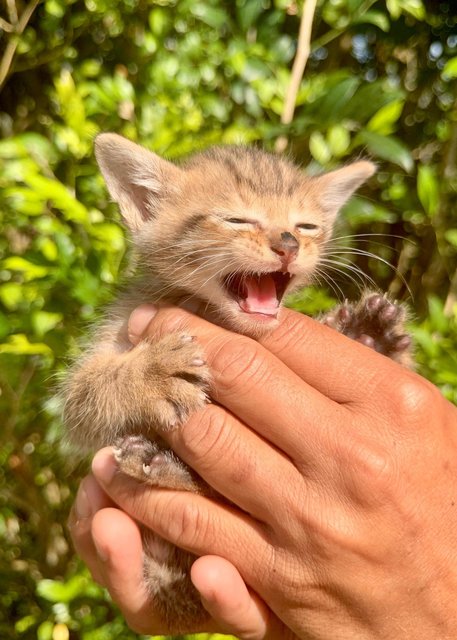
left=70, top=306, right=457, bottom=640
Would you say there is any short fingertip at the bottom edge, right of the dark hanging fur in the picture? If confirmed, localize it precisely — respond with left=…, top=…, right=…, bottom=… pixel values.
left=191, top=556, right=294, bottom=640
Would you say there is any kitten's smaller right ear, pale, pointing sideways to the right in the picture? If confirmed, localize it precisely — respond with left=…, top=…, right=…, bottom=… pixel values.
left=315, top=160, right=376, bottom=222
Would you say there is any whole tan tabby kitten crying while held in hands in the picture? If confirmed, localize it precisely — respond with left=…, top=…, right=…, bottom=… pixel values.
left=64, top=134, right=409, bottom=632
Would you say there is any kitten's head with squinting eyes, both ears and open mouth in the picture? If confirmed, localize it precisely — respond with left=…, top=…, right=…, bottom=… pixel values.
left=97, top=134, right=374, bottom=337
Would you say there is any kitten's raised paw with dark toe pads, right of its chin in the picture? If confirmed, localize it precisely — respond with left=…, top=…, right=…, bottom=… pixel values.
left=322, top=293, right=411, bottom=366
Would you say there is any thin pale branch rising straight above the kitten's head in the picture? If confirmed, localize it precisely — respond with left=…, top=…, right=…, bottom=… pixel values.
left=275, top=0, right=317, bottom=153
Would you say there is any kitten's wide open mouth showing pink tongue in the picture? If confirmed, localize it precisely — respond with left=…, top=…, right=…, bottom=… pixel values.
left=224, top=271, right=292, bottom=316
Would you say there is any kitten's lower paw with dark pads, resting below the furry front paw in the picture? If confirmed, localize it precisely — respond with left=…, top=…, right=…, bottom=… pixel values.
left=114, top=434, right=203, bottom=493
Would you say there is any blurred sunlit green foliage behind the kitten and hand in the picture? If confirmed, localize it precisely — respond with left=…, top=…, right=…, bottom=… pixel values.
left=0, top=0, right=457, bottom=640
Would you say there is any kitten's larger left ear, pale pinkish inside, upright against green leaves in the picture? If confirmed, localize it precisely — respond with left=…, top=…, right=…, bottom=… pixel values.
left=95, top=133, right=181, bottom=231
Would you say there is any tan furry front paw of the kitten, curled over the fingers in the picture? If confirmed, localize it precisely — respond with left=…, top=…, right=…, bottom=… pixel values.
left=136, top=333, right=210, bottom=429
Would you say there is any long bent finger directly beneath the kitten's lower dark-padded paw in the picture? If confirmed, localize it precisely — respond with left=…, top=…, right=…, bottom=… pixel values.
left=92, top=448, right=269, bottom=574
